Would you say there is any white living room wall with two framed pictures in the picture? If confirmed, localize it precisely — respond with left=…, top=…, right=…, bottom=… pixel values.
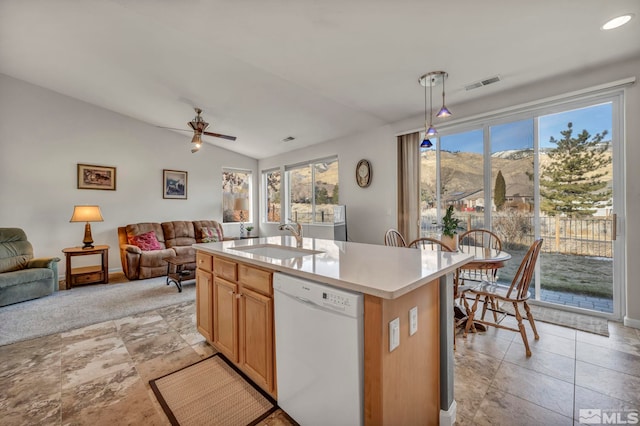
left=0, top=74, right=257, bottom=276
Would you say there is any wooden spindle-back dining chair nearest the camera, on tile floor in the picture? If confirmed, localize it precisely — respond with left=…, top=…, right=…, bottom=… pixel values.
left=462, top=238, right=542, bottom=357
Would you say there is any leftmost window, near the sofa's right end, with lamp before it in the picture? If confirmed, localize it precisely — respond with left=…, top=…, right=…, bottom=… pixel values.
left=222, top=169, right=251, bottom=223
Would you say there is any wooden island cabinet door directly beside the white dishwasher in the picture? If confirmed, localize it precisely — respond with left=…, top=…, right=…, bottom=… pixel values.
left=240, top=288, right=274, bottom=392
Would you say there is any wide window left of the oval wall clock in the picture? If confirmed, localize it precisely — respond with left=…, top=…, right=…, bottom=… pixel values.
left=286, top=158, right=339, bottom=223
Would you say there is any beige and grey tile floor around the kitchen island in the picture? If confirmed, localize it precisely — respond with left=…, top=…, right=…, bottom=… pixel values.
left=0, top=302, right=640, bottom=426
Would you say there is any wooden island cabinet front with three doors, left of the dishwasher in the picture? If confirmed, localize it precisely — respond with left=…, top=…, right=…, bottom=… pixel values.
left=196, top=252, right=277, bottom=398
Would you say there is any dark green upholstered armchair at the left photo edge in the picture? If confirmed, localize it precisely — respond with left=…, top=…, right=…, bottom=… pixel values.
left=0, top=228, right=60, bottom=306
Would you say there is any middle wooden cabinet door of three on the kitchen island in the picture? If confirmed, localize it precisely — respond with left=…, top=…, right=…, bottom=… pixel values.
left=213, top=277, right=238, bottom=362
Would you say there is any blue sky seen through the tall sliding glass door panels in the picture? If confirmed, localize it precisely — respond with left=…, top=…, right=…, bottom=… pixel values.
left=441, top=103, right=612, bottom=153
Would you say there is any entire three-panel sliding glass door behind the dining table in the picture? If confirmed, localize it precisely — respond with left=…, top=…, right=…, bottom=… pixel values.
left=421, top=95, right=624, bottom=318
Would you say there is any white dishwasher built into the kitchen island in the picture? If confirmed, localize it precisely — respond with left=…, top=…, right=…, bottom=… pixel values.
left=273, top=273, right=364, bottom=426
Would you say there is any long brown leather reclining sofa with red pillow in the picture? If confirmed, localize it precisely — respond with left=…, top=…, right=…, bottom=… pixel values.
left=118, top=220, right=233, bottom=280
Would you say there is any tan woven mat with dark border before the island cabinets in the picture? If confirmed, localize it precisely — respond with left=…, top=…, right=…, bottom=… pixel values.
left=149, top=353, right=278, bottom=426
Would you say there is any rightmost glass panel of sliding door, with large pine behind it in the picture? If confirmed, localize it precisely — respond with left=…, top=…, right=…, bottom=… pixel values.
left=536, top=102, right=619, bottom=313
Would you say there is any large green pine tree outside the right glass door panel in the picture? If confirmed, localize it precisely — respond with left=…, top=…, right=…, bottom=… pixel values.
left=540, top=123, right=612, bottom=216
